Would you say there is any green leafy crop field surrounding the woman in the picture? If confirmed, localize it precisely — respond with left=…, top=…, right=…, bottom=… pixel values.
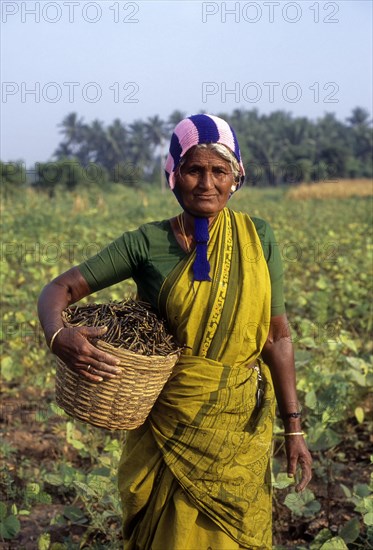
left=0, top=182, right=373, bottom=550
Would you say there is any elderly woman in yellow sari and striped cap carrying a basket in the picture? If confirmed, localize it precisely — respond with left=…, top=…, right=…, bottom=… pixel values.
left=39, top=114, right=311, bottom=550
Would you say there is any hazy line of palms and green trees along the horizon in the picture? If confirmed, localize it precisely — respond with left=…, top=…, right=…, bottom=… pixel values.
left=1, top=107, right=373, bottom=193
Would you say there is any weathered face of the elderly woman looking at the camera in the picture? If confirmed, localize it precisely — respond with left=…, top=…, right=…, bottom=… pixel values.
left=174, top=147, right=234, bottom=222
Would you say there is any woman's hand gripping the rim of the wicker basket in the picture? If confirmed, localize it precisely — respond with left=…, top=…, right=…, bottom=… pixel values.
left=53, top=327, right=121, bottom=382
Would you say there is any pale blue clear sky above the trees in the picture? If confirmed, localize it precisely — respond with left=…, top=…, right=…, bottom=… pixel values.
left=0, top=0, right=373, bottom=167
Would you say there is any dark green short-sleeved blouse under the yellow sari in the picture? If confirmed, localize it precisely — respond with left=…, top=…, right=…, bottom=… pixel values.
left=78, top=218, right=285, bottom=316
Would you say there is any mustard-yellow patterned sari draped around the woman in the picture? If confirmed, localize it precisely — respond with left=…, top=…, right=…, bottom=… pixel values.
left=119, top=208, right=274, bottom=550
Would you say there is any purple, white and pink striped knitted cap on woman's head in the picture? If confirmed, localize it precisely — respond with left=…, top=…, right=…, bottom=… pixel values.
left=165, top=115, right=245, bottom=189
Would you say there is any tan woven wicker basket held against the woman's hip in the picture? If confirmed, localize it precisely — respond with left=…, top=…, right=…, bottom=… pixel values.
left=56, top=340, right=179, bottom=430
